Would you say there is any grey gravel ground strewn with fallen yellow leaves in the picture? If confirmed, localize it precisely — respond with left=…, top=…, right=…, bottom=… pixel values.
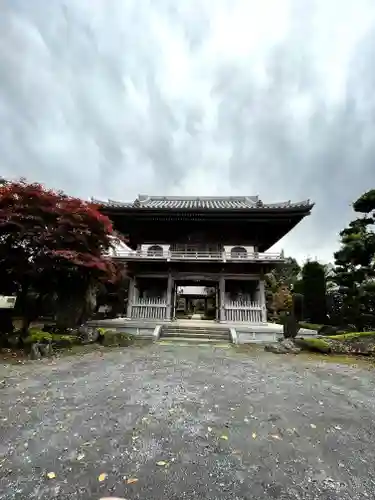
left=0, top=342, right=375, bottom=500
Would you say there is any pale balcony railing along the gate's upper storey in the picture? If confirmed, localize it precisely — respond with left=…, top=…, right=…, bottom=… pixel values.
left=112, top=249, right=284, bottom=262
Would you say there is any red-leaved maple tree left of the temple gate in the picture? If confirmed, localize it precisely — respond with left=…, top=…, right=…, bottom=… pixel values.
left=0, top=179, right=125, bottom=330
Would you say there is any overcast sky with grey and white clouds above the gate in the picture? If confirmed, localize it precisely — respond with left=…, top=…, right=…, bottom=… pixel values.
left=0, top=0, right=375, bottom=261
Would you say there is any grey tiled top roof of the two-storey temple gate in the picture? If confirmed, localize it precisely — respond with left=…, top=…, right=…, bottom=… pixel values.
left=92, top=195, right=313, bottom=210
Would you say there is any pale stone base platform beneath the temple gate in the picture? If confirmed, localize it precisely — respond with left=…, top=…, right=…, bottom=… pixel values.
left=87, top=318, right=317, bottom=344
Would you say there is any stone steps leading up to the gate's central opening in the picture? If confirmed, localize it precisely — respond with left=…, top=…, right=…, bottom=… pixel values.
left=160, top=323, right=232, bottom=343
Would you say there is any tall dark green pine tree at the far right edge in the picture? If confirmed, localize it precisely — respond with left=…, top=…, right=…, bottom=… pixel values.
left=334, top=189, right=375, bottom=331
